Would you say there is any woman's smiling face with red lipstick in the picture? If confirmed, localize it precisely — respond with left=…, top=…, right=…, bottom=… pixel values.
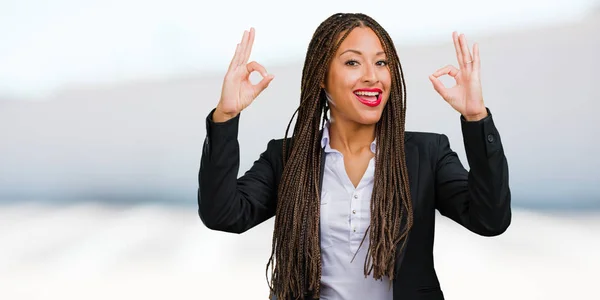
left=324, top=27, right=391, bottom=125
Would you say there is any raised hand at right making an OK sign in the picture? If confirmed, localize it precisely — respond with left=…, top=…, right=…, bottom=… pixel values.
left=429, top=31, right=487, bottom=121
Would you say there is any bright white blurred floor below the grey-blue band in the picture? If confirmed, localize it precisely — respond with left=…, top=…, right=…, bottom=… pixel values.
left=0, top=203, right=600, bottom=300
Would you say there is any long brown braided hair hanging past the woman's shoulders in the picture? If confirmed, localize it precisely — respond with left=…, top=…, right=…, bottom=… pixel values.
left=267, top=14, right=413, bottom=300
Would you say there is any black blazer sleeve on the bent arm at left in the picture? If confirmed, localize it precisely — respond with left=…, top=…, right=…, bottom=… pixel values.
left=198, top=109, right=277, bottom=233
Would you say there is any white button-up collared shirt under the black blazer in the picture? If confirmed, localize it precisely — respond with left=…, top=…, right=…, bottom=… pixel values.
left=320, top=123, right=393, bottom=300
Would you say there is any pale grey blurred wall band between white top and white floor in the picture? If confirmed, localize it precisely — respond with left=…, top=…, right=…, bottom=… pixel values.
left=0, top=12, right=600, bottom=209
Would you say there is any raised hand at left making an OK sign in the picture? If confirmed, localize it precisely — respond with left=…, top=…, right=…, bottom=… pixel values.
left=213, top=28, right=274, bottom=122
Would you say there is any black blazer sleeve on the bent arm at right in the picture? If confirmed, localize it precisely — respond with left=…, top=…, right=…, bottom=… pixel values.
left=435, top=109, right=511, bottom=236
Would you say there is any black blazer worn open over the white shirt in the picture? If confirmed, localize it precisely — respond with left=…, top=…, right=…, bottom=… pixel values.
left=198, top=109, right=511, bottom=300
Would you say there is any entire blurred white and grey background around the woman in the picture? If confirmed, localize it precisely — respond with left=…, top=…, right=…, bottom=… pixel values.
left=0, top=0, right=600, bottom=299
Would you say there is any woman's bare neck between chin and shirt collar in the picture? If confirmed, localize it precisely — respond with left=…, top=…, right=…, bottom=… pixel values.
left=329, top=119, right=375, bottom=155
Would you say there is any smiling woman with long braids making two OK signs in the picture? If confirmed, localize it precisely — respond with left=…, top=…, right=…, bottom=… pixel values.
left=198, top=14, right=511, bottom=300
